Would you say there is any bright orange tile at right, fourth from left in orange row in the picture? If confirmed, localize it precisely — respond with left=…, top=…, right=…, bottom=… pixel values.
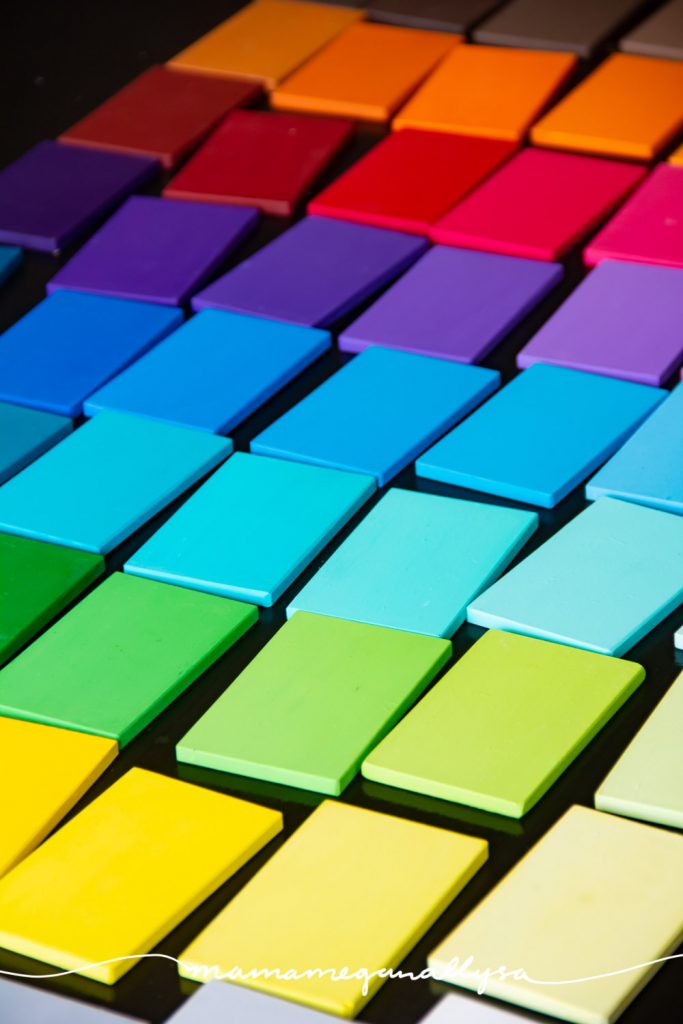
left=531, top=53, right=683, bottom=160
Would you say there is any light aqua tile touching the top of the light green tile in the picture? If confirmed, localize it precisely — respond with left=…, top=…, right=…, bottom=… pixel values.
left=287, top=487, right=539, bottom=637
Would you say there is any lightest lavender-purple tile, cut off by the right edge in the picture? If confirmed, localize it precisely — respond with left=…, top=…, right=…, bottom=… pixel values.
left=517, top=260, right=683, bottom=386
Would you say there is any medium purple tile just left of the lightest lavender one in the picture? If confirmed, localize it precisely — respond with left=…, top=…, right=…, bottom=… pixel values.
left=339, top=246, right=564, bottom=362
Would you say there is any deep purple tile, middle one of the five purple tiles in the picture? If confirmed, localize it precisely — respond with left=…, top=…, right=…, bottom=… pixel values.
left=193, top=217, right=427, bottom=327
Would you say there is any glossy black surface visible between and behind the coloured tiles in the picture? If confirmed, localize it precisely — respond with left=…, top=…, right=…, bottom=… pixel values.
left=0, top=0, right=683, bottom=1024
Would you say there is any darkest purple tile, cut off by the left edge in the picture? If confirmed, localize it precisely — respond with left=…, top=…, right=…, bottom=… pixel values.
left=0, top=141, right=159, bottom=252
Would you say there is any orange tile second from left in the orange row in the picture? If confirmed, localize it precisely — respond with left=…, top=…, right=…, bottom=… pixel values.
left=270, top=24, right=460, bottom=122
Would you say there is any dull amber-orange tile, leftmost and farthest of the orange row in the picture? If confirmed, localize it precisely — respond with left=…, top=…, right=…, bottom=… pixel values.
left=169, top=0, right=364, bottom=89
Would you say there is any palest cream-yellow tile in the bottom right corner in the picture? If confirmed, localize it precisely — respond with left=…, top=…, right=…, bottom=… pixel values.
left=428, top=806, right=683, bottom=1024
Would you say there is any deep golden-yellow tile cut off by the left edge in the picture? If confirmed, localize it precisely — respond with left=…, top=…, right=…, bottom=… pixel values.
left=0, top=718, right=119, bottom=880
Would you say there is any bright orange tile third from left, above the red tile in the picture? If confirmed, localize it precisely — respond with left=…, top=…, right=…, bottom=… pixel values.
left=393, top=46, right=577, bottom=141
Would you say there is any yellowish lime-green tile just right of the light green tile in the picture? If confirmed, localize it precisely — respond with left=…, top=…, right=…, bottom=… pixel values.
left=366, top=630, right=645, bottom=818
